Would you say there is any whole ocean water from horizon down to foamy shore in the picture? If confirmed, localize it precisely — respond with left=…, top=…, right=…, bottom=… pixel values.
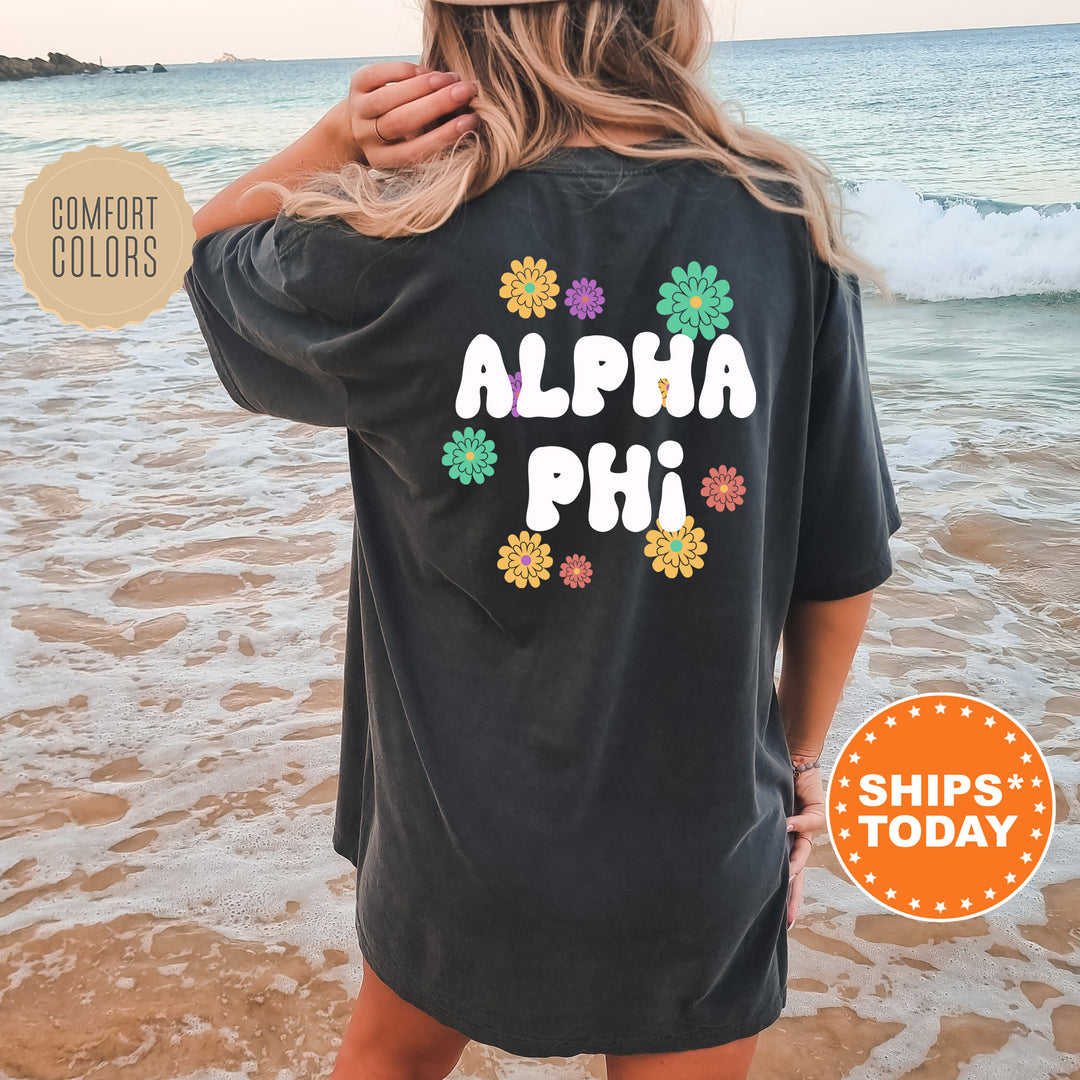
left=0, top=24, right=1080, bottom=1080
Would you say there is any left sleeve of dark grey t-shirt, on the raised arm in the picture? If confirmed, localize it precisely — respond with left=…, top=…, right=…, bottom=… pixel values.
left=184, top=214, right=347, bottom=428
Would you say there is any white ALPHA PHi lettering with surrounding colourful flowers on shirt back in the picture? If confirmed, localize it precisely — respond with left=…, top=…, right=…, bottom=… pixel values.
left=442, top=255, right=757, bottom=589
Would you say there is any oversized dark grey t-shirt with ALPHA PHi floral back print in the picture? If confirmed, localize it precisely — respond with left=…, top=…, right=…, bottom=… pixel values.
left=185, top=139, right=901, bottom=1056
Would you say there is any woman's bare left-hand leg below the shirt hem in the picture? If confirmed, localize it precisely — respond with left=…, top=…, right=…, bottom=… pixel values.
left=328, top=960, right=469, bottom=1080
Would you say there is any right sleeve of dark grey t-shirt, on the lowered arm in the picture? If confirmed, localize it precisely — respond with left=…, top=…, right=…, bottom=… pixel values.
left=792, top=267, right=901, bottom=600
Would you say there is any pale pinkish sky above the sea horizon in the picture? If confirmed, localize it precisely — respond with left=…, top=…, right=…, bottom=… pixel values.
left=6, top=0, right=1077, bottom=66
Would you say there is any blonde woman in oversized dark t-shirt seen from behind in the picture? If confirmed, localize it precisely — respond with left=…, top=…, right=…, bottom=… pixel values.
left=185, top=0, right=900, bottom=1080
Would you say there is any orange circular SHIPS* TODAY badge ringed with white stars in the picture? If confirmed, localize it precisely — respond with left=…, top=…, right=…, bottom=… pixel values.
left=826, top=693, right=1054, bottom=922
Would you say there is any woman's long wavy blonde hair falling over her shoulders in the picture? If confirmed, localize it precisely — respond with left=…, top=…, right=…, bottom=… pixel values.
left=254, top=0, right=892, bottom=299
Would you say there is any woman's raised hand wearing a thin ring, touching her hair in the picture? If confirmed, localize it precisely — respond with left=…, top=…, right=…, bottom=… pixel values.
left=341, top=60, right=477, bottom=170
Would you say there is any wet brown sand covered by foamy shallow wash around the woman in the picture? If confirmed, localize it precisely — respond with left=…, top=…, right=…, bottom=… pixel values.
left=0, top=297, right=1080, bottom=1080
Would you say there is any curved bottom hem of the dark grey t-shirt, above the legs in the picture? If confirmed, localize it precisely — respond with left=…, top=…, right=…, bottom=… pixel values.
left=356, top=912, right=787, bottom=1057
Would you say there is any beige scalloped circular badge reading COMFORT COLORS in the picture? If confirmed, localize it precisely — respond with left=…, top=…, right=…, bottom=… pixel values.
left=11, top=146, right=195, bottom=330
